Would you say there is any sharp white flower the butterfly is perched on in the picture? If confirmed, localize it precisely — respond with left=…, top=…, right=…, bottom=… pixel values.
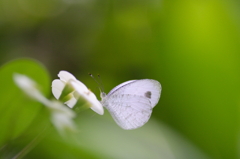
left=52, top=71, right=104, bottom=115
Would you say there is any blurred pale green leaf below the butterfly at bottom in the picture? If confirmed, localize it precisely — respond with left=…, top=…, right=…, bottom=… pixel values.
left=23, top=111, right=209, bottom=159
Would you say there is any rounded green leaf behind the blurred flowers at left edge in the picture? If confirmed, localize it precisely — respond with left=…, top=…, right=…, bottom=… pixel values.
left=0, top=59, right=50, bottom=146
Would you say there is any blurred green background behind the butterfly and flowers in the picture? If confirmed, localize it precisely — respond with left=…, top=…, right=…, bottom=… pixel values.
left=0, top=0, right=240, bottom=159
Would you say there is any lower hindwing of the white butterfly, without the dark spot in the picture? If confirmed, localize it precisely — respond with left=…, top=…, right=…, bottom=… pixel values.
left=105, top=94, right=152, bottom=129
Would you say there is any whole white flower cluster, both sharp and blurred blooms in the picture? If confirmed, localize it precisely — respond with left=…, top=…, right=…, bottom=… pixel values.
left=13, top=71, right=104, bottom=133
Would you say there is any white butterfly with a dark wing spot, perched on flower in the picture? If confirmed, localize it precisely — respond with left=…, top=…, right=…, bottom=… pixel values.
left=101, top=79, right=162, bottom=130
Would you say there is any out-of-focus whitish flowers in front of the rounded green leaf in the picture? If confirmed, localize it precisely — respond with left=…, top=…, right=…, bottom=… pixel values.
left=13, top=73, right=75, bottom=134
